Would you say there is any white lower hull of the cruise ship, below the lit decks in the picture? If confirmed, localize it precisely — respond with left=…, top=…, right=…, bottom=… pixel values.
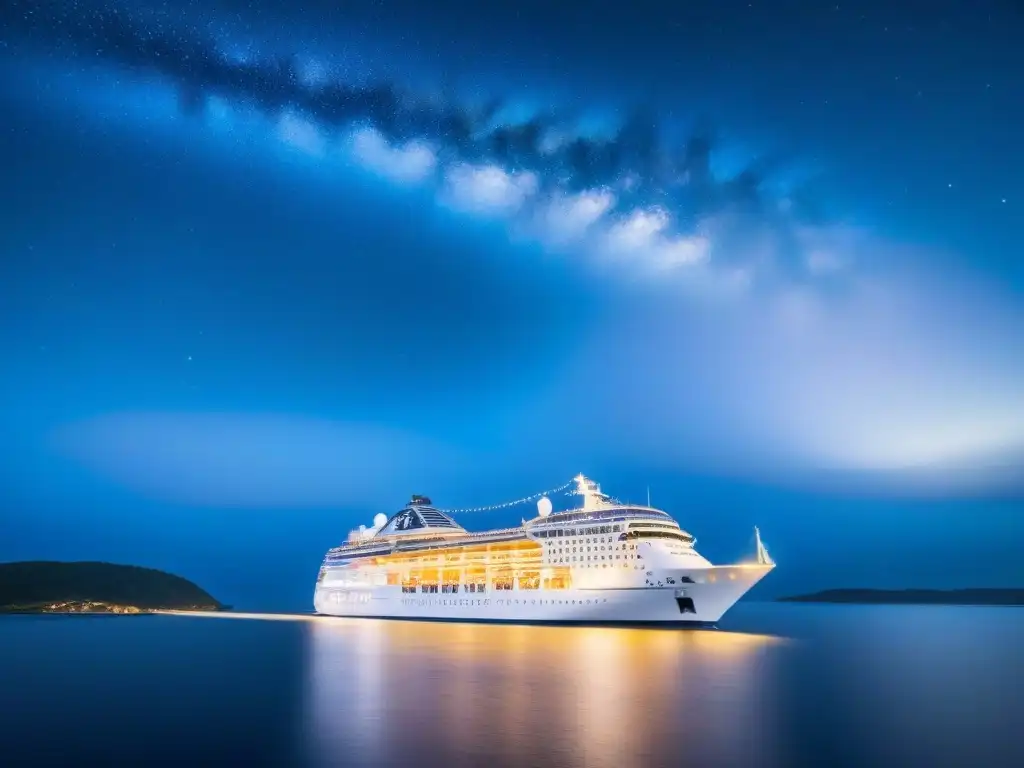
left=313, top=564, right=773, bottom=626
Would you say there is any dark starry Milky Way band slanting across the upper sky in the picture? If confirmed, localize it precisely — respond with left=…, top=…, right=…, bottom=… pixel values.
left=7, top=0, right=835, bottom=276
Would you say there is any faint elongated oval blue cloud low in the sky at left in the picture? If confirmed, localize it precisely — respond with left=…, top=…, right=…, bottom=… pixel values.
left=53, top=413, right=458, bottom=510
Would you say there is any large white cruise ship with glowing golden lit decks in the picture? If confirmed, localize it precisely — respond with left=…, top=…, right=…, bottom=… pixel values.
left=313, top=475, right=775, bottom=626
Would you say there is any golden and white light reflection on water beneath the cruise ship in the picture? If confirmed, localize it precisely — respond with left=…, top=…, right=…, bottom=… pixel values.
left=305, top=620, right=786, bottom=768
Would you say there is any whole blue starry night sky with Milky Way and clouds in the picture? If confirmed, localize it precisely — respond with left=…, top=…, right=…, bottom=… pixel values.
left=0, top=0, right=1024, bottom=610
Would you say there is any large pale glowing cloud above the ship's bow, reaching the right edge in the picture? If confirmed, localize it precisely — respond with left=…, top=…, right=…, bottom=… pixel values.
left=517, top=264, right=1024, bottom=493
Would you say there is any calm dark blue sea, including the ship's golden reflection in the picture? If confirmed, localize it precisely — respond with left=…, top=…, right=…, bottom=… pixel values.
left=0, top=603, right=1024, bottom=768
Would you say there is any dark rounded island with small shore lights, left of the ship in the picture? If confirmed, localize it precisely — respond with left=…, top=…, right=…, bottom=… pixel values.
left=0, top=560, right=227, bottom=614
